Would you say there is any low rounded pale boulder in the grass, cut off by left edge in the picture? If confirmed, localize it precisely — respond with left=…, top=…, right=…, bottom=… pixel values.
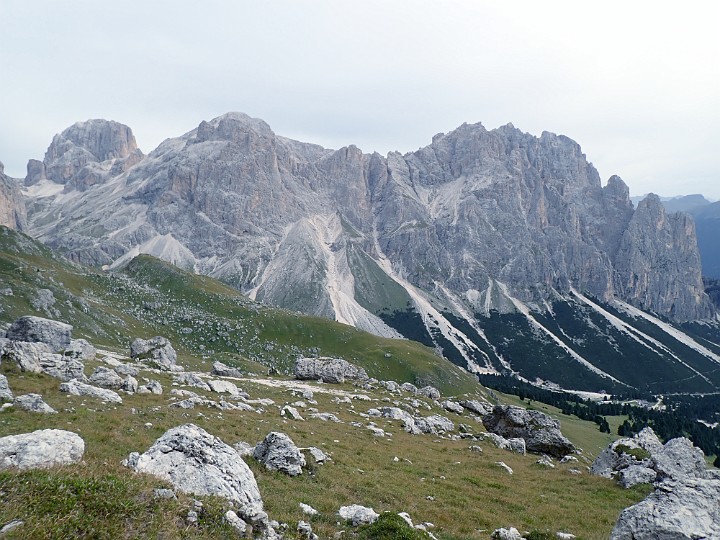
left=0, top=429, right=85, bottom=470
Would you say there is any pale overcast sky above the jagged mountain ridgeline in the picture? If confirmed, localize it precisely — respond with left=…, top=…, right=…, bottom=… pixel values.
left=0, top=0, right=720, bottom=199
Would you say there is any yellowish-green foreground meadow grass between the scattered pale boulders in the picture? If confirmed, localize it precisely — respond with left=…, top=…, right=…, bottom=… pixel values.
left=0, top=363, right=646, bottom=540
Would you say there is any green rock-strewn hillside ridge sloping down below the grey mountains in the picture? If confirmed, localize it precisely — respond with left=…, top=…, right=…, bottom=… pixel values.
left=0, top=228, right=477, bottom=393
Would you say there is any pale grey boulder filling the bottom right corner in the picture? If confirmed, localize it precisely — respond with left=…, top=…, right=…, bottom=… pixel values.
left=610, top=478, right=720, bottom=540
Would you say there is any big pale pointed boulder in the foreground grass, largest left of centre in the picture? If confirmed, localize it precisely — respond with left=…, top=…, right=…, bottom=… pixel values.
left=127, top=424, right=268, bottom=528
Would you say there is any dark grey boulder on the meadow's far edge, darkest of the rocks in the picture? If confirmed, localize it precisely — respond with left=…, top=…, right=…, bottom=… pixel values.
left=483, top=405, right=575, bottom=457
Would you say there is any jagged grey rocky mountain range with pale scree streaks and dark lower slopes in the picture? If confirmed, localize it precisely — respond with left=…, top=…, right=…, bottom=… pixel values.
left=0, top=113, right=720, bottom=392
